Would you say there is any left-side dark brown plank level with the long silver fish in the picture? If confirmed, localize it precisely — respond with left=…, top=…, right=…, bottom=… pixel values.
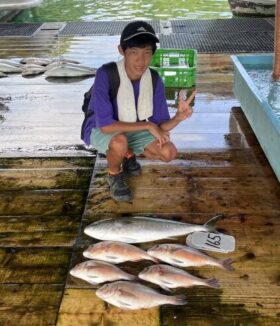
left=0, top=216, right=80, bottom=247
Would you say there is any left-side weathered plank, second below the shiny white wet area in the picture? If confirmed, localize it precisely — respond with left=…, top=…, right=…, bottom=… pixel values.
left=0, top=168, right=92, bottom=191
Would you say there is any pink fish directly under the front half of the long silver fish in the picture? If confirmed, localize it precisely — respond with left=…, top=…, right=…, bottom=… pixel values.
left=83, top=241, right=158, bottom=264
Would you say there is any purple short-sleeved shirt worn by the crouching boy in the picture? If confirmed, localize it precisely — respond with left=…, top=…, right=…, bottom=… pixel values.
left=80, top=67, right=170, bottom=145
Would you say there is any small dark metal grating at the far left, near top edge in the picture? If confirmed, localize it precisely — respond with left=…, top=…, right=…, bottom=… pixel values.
left=0, top=23, right=42, bottom=36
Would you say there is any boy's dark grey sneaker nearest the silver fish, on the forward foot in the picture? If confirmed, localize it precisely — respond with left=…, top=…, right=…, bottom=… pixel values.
left=108, top=172, right=132, bottom=201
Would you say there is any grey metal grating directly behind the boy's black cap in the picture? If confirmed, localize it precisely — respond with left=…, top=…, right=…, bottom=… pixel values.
left=58, top=21, right=160, bottom=36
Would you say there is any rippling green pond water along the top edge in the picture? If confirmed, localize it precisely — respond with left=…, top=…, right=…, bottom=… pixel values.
left=13, top=0, right=232, bottom=23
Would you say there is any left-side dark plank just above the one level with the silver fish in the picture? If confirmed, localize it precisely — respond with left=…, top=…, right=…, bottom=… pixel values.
left=0, top=190, right=87, bottom=216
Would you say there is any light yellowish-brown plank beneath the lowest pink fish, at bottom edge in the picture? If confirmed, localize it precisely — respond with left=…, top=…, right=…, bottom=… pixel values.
left=57, top=289, right=160, bottom=326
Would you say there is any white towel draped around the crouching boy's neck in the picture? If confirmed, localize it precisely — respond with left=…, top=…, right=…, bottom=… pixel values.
left=117, top=60, right=153, bottom=122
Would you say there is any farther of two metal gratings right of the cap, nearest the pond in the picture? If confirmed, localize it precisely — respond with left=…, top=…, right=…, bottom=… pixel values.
left=171, top=18, right=274, bottom=34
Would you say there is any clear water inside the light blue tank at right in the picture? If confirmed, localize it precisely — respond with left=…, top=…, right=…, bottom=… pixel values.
left=247, top=68, right=280, bottom=119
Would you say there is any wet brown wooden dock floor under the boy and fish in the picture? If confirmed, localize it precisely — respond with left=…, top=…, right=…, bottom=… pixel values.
left=0, top=26, right=280, bottom=326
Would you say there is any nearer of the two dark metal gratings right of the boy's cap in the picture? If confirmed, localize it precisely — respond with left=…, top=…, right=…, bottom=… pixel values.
left=159, top=32, right=274, bottom=53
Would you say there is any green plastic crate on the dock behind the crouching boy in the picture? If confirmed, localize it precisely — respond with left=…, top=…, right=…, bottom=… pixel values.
left=150, top=49, right=197, bottom=88
